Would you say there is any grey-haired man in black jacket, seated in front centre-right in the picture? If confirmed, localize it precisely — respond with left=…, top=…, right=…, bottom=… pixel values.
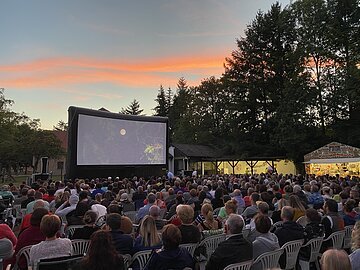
left=206, top=214, right=253, bottom=270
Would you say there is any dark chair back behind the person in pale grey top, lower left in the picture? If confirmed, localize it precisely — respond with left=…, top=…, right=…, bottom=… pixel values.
left=34, top=255, right=83, bottom=270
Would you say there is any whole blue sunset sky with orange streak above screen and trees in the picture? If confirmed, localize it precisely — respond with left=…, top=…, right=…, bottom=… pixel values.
left=0, top=0, right=290, bottom=129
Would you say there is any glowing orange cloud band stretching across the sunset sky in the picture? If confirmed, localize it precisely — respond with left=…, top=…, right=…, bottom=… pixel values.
left=0, top=55, right=224, bottom=88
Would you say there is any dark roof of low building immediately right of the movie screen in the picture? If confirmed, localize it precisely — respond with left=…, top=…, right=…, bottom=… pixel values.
left=172, top=143, right=218, bottom=158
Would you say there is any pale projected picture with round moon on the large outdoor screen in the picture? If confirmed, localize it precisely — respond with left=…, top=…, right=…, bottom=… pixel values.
left=77, top=114, right=167, bottom=165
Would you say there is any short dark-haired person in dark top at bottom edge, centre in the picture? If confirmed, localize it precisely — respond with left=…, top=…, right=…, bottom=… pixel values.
left=145, top=224, right=195, bottom=270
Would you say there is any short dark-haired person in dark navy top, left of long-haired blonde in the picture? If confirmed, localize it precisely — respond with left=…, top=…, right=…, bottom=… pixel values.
left=106, top=213, right=133, bottom=254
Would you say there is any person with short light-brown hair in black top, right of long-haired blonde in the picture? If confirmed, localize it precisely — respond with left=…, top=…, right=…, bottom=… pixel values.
left=176, top=204, right=201, bottom=244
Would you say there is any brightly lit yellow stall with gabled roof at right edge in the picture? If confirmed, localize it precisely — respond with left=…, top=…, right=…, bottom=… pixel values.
left=304, top=142, right=360, bottom=176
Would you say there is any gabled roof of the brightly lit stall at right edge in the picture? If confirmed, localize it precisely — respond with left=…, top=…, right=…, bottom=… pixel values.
left=304, top=142, right=360, bottom=162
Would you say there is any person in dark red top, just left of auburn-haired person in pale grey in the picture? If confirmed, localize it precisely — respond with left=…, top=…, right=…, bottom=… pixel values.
left=11, top=208, right=49, bottom=270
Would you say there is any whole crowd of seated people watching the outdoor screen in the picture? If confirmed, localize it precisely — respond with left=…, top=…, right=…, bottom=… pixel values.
left=0, top=174, right=360, bottom=269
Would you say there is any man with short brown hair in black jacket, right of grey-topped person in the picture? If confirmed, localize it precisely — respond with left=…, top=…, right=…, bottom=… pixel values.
left=275, top=206, right=304, bottom=269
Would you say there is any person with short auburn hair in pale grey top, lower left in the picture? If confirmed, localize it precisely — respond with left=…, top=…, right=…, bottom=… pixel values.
left=30, top=215, right=72, bottom=269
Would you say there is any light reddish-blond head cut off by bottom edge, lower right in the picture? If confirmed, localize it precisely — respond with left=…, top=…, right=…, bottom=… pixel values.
left=320, top=249, right=351, bottom=270
